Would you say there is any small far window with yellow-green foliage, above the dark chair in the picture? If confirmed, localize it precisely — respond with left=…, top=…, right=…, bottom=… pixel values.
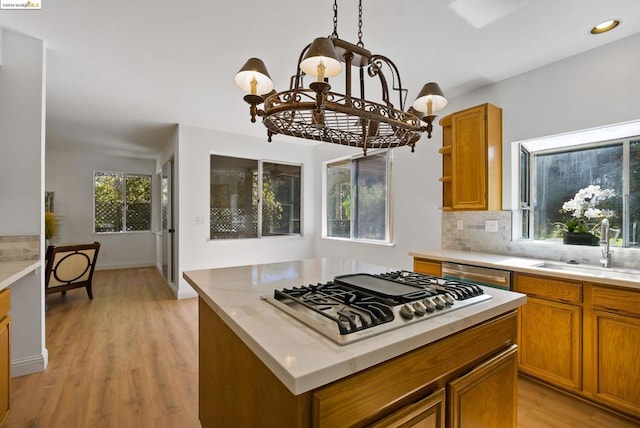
left=93, top=172, right=151, bottom=233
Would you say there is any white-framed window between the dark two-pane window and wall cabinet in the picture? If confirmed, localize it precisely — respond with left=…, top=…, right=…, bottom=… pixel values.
left=324, top=151, right=391, bottom=242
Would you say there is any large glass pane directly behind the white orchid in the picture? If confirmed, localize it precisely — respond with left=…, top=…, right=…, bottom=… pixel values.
left=534, top=144, right=623, bottom=239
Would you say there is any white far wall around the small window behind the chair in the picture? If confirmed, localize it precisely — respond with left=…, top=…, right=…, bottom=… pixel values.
left=45, top=150, right=159, bottom=269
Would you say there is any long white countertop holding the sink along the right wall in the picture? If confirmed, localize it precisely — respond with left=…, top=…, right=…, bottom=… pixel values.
left=409, top=248, right=640, bottom=290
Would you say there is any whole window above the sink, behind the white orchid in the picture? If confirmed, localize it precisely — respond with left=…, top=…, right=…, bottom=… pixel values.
left=520, top=137, right=640, bottom=247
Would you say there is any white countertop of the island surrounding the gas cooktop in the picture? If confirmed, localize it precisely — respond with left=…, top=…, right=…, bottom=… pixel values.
left=183, top=259, right=526, bottom=395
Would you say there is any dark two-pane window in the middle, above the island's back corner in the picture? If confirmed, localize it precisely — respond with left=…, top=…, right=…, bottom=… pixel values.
left=209, top=155, right=302, bottom=239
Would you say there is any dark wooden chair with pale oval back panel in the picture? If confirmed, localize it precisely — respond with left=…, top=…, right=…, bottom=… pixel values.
left=44, top=242, right=100, bottom=299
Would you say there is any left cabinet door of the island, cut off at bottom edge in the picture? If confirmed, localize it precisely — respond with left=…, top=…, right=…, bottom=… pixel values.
left=372, top=388, right=445, bottom=428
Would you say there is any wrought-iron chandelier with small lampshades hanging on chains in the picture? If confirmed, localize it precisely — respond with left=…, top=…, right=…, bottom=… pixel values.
left=234, top=0, right=447, bottom=155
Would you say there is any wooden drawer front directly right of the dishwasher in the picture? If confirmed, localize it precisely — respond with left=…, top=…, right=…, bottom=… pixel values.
left=513, top=274, right=582, bottom=303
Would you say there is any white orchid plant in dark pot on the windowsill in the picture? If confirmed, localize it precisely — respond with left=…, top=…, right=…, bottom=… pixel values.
left=560, top=185, right=615, bottom=232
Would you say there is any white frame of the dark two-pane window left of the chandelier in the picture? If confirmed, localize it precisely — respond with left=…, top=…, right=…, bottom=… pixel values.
left=207, top=153, right=304, bottom=242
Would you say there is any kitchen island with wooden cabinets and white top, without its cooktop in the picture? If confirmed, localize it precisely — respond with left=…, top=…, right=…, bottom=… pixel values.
left=184, top=259, right=526, bottom=427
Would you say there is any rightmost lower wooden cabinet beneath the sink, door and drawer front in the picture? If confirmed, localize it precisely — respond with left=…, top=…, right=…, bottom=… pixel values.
left=585, top=285, right=640, bottom=418
